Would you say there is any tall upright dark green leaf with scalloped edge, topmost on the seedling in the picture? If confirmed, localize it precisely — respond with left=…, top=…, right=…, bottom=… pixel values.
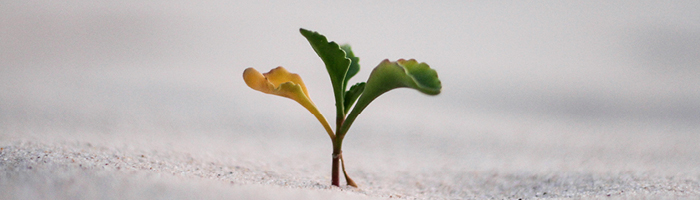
left=299, top=28, right=351, bottom=119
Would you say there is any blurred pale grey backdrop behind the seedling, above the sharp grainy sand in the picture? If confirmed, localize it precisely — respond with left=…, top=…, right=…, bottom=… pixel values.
left=0, top=0, right=700, bottom=174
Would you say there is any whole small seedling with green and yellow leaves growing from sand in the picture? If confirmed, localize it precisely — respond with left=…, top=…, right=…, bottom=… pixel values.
left=243, top=29, right=442, bottom=187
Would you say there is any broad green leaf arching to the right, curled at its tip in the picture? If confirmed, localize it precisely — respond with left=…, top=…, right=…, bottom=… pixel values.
left=336, top=59, right=442, bottom=139
